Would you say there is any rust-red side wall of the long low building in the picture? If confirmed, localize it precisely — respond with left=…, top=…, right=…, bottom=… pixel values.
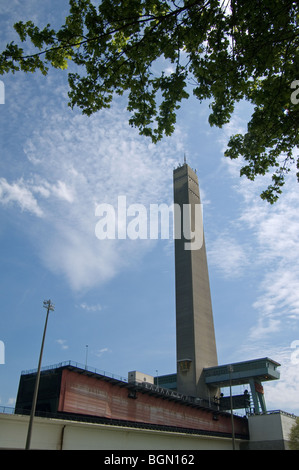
left=58, top=369, right=248, bottom=435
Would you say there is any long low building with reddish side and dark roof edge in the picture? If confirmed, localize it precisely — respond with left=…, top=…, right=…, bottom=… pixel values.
left=15, top=362, right=248, bottom=450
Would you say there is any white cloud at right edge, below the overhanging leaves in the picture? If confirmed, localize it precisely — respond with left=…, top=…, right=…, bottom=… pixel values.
left=240, top=178, right=299, bottom=337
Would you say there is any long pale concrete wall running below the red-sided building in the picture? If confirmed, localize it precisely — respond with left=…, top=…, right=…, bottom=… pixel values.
left=0, top=414, right=244, bottom=451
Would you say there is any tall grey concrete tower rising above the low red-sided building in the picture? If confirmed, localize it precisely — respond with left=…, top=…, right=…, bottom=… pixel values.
left=173, top=163, right=218, bottom=399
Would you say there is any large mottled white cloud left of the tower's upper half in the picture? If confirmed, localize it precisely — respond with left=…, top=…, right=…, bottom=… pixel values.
left=0, top=97, right=183, bottom=290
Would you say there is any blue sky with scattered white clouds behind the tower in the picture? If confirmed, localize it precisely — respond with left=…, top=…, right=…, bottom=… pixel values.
left=0, top=0, right=299, bottom=415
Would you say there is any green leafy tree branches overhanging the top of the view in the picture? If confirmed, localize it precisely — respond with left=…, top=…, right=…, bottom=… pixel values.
left=0, top=0, right=299, bottom=203
